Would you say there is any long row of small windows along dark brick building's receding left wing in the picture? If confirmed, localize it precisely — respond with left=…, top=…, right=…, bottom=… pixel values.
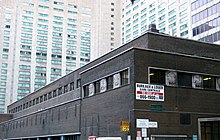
left=9, top=79, right=81, bottom=113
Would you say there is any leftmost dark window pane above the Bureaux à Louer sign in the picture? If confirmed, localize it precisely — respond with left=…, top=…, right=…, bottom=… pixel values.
left=149, top=69, right=165, bottom=85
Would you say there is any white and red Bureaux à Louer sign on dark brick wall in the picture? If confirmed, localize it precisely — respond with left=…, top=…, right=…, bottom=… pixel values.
left=136, top=83, right=164, bottom=101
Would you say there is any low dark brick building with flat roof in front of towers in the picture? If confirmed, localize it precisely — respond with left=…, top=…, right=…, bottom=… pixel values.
left=0, top=32, right=220, bottom=140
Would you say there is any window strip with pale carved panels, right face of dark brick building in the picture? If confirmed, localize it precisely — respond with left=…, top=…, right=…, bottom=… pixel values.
left=149, top=68, right=220, bottom=91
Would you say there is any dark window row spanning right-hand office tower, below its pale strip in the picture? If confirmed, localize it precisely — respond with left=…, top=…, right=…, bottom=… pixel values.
left=193, top=17, right=220, bottom=36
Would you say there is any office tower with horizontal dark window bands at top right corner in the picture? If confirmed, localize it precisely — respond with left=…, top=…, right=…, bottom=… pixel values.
left=191, top=0, right=220, bottom=44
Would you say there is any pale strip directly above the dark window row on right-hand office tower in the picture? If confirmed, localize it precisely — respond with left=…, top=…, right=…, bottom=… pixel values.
left=192, top=3, right=220, bottom=23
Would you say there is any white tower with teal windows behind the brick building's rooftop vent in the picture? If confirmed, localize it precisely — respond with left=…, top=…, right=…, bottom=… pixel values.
left=122, top=0, right=191, bottom=44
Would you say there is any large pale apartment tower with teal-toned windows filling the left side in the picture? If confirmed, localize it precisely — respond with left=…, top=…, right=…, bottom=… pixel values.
left=0, top=0, right=121, bottom=113
